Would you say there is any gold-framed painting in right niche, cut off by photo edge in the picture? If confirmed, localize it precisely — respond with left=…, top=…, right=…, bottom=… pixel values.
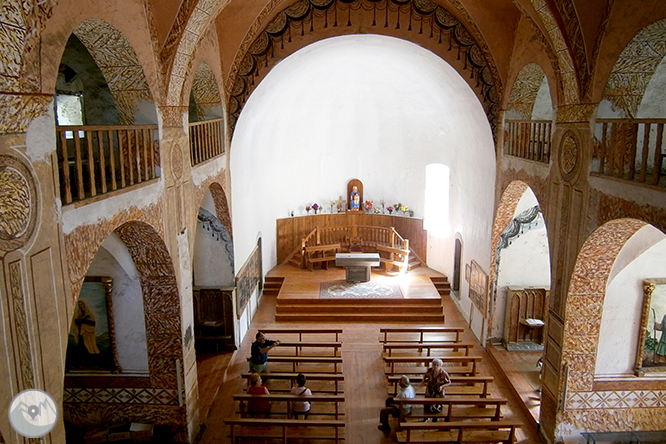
left=635, top=279, right=666, bottom=376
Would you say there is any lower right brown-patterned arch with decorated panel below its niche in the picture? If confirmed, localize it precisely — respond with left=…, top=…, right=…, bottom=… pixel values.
left=553, top=218, right=665, bottom=433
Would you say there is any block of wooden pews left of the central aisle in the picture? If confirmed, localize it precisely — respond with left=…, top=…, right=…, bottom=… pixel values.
left=225, top=328, right=345, bottom=444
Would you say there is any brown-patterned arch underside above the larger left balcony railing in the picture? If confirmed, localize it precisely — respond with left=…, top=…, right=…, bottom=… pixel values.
left=73, top=18, right=154, bottom=125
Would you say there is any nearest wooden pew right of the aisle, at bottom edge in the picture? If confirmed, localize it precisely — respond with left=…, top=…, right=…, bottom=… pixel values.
left=396, top=421, right=521, bottom=444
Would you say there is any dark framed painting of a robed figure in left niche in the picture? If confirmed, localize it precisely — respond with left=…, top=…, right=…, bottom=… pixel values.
left=65, top=276, right=119, bottom=374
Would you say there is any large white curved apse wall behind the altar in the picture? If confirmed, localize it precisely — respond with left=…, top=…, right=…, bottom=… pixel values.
left=230, top=35, right=495, bottom=299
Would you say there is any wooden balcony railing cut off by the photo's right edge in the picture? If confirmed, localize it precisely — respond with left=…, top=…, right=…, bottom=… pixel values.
left=592, top=119, right=666, bottom=187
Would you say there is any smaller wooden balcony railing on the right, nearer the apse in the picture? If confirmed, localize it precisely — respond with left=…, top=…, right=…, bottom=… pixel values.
left=504, top=120, right=553, bottom=164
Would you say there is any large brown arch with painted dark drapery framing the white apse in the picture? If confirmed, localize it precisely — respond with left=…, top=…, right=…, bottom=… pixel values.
left=225, top=0, right=502, bottom=137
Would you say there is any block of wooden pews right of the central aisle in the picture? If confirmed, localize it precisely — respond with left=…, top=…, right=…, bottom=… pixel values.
left=379, top=327, right=520, bottom=444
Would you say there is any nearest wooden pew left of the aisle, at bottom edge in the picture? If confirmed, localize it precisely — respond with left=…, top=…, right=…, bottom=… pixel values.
left=224, top=418, right=345, bottom=444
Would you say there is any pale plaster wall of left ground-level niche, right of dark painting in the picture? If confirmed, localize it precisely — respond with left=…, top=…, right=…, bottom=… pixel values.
left=87, top=234, right=148, bottom=374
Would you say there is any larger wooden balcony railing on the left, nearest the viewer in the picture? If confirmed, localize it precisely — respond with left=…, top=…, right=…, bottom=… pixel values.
left=56, top=125, right=160, bottom=204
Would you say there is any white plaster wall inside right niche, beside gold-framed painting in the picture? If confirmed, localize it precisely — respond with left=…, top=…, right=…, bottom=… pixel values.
left=595, top=226, right=666, bottom=378
